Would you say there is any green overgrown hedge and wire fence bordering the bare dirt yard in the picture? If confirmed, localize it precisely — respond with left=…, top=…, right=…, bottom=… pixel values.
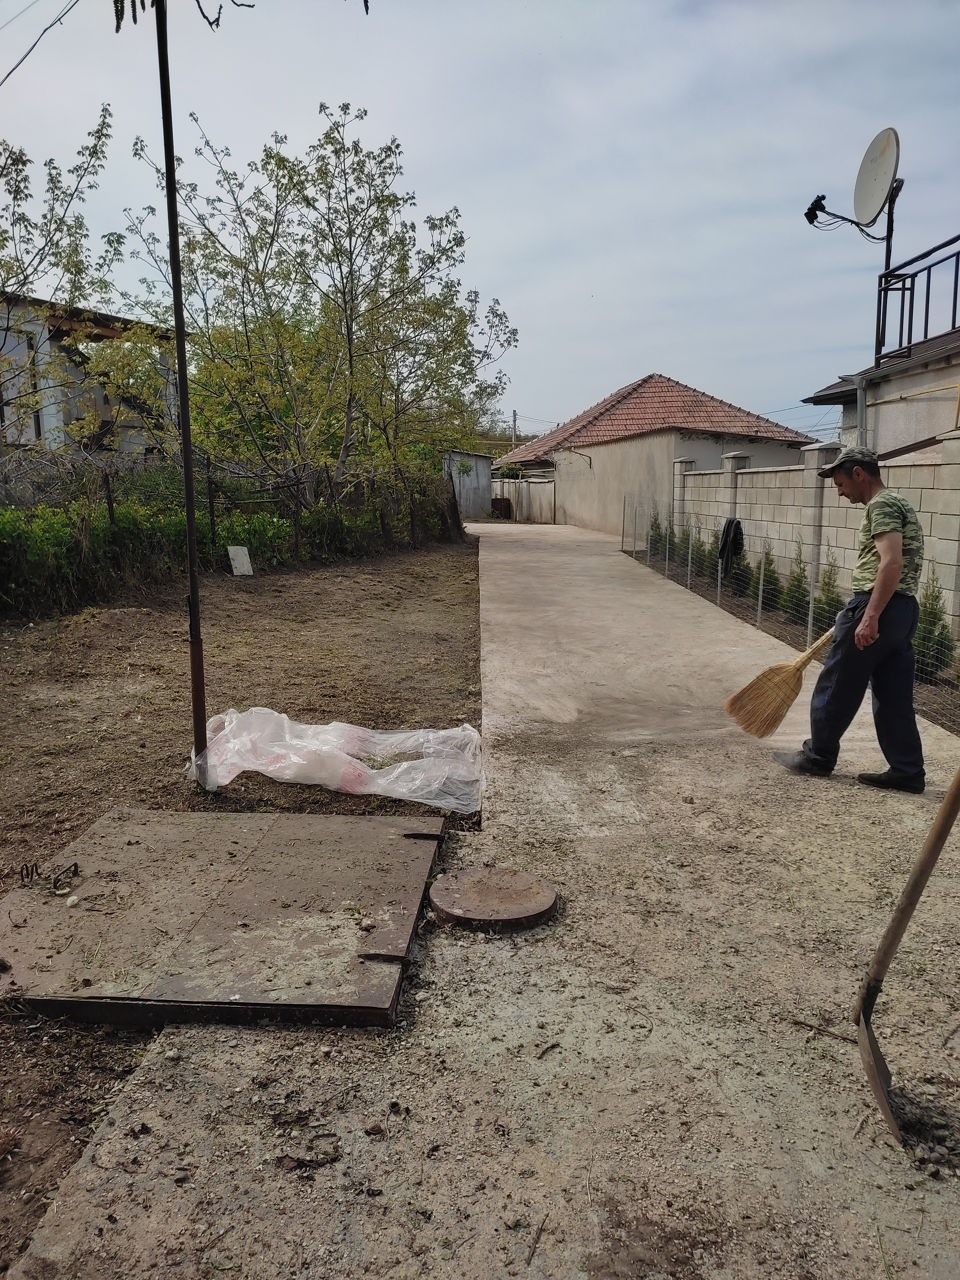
left=0, top=452, right=462, bottom=618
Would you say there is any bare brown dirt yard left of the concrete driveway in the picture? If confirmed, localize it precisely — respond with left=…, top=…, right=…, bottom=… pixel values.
left=0, top=541, right=480, bottom=1274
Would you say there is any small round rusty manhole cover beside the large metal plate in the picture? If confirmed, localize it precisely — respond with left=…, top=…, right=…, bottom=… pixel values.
left=430, top=867, right=557, bottom=929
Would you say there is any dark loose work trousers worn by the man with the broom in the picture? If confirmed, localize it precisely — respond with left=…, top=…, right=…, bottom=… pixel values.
left=804, top=591, right=923, bottom=777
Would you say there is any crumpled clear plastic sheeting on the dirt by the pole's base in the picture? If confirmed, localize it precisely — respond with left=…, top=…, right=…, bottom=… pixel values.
left=187, top=707, right=481, bottom=813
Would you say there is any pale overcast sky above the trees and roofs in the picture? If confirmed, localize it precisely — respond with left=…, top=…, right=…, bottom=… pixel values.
left=0, top=0, right=960, bottom=434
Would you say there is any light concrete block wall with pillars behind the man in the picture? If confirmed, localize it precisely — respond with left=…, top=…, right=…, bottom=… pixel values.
left=672, top=431, right=960, bottom=636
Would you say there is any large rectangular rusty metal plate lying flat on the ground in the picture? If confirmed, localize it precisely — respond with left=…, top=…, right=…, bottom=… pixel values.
left=0, top=809, right=443, bottom=1025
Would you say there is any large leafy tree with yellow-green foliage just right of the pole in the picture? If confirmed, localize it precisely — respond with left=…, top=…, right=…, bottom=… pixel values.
left=129, top=104, right=516, bottom=503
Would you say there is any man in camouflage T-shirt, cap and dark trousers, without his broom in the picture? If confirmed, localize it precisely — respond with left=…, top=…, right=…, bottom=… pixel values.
left=774, top=448, right=924, bottom=795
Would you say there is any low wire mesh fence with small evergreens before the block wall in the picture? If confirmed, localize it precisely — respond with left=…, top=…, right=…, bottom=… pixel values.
left=621, top=498, right=960, bottom=733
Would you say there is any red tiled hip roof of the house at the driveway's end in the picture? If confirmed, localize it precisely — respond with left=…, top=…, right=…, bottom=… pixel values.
left=495, top=374, right=813, bottom=466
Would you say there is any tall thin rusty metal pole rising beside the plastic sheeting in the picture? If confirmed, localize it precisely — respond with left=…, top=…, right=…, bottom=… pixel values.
left=154, top=0, right=206, bottom=782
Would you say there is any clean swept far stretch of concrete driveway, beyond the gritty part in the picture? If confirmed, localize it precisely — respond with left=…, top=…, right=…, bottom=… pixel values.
left=471, top=525, right=960, bottom=831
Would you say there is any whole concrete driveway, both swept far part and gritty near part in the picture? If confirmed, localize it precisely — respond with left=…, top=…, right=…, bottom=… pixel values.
left=13, top=525, right=960, bottom=1280
